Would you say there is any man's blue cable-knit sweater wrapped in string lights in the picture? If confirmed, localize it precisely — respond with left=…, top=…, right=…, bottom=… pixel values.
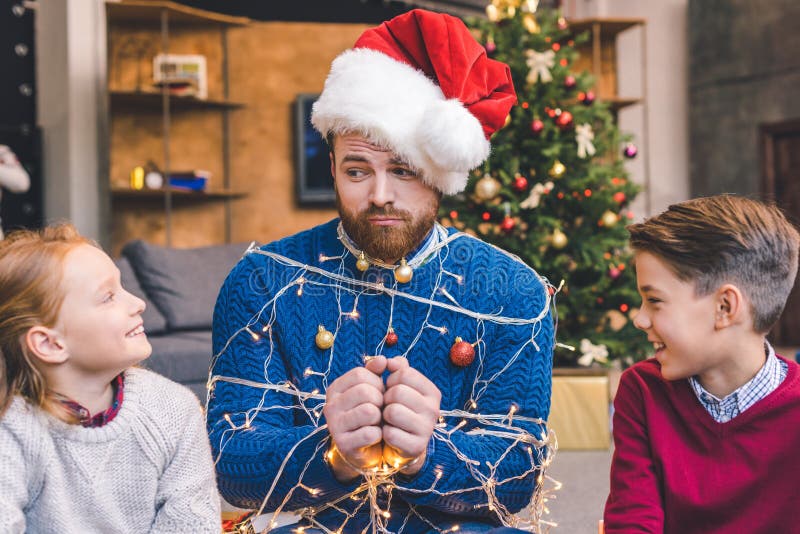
left=208, top=220, right=553, bottom=532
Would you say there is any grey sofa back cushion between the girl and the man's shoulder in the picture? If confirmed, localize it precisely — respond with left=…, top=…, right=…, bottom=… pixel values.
left=122, top=240, right=247, bottom=330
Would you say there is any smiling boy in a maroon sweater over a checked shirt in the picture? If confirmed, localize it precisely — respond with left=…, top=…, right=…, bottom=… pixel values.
left=604, top=195, right=800, bottom=534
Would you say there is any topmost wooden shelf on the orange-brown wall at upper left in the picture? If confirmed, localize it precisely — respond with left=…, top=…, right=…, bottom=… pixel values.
left=106, top=0, right=250, bottom=26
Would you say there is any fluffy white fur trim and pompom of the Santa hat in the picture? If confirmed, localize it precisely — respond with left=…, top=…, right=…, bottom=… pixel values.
left=311, top=48, right=490, bottom=195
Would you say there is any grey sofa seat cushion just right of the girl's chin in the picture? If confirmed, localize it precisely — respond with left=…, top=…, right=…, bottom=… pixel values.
left=142, top=330, right=213, bottom=384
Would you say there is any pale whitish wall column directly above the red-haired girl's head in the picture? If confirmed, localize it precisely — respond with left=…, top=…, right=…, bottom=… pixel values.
left=36, top=0, right=107, bottom=241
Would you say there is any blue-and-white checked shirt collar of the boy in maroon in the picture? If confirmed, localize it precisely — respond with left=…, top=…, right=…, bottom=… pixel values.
left=689, top=342, right=788, bottom=423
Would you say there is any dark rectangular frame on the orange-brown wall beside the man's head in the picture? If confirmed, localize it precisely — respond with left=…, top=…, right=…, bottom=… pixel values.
left=294, top=93, right=336, bottom=207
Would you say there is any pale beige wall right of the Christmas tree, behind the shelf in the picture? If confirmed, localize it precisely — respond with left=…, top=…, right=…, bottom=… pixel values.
left=563, top=0, right=695, bottom=220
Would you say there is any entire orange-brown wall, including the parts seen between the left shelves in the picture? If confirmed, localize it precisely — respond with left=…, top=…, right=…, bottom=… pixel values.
left=108, top=22, right=368, bottom=254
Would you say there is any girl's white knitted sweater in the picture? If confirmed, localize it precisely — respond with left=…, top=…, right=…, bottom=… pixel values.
left=0, top=369, right=221, bottom=534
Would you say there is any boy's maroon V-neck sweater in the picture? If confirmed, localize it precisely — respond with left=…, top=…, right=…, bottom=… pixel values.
left=605, top=357, right=800, bottom=534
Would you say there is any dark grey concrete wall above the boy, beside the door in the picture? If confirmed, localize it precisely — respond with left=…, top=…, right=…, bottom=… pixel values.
left=689, top=0, right=800, bottom=195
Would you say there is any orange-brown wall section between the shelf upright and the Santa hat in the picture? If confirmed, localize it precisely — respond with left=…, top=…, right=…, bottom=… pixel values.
left=222, top=22, right=368, bottom=243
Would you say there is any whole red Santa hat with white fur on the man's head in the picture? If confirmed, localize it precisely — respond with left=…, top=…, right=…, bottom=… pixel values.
left=311, top=9, right=516, bottom=194
